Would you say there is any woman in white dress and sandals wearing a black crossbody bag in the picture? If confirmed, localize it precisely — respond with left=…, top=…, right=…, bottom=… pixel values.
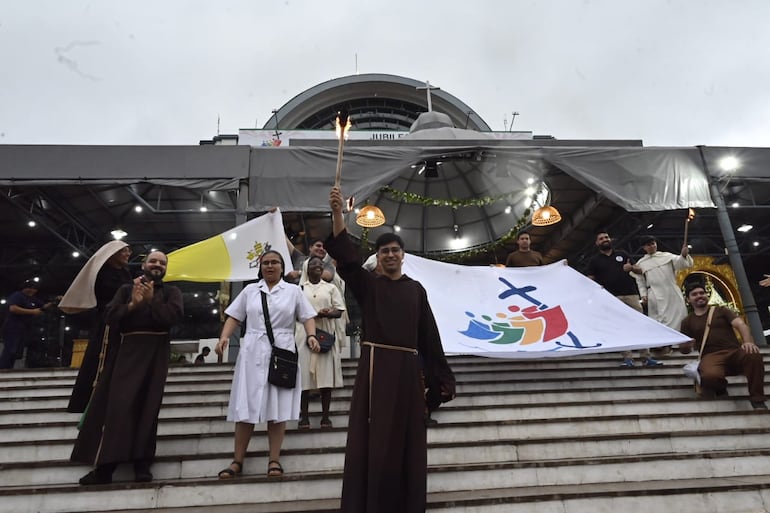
left=216, top=251, right=320, bottom=479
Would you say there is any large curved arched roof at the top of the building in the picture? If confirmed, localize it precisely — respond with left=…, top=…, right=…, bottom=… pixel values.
left=264, top=73, right=491, bottom=132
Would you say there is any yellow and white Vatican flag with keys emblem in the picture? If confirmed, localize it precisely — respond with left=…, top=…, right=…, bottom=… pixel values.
left=164, top=209, right=292, bottom=282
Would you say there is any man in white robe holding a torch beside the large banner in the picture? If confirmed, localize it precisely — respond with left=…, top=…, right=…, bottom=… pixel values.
left=631, top=235, right=693, bottom=330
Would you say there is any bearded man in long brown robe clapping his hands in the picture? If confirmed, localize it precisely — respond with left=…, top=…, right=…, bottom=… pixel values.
left=70, top=251, right=183, bottom=485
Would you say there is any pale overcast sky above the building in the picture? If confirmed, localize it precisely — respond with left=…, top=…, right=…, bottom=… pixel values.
left=0, top=0, right=770, bottom=146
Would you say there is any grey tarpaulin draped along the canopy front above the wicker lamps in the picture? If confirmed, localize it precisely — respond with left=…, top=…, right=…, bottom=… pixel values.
left=249, top=141, right=714, bottom=211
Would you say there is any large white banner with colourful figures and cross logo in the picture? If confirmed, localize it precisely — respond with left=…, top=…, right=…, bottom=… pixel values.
left=403, top=255, right=690, bottom=358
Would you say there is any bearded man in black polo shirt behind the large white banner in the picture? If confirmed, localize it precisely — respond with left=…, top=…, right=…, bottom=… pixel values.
left=588, top=232, right=663, bottom=367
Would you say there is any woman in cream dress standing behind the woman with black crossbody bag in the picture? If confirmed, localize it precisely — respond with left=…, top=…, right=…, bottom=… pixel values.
left=296, top=257, right=345, bottom=429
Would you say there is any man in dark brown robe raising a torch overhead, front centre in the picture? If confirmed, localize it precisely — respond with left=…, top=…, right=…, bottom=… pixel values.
left=325, top=187, right=455, bottom=513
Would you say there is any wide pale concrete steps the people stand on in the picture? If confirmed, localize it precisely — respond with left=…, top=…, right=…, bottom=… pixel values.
left=0, top=352, right=770, bottom=513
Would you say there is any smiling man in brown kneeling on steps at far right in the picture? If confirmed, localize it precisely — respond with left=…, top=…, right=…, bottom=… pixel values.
left=679, top=283, right=767, bottom=410
